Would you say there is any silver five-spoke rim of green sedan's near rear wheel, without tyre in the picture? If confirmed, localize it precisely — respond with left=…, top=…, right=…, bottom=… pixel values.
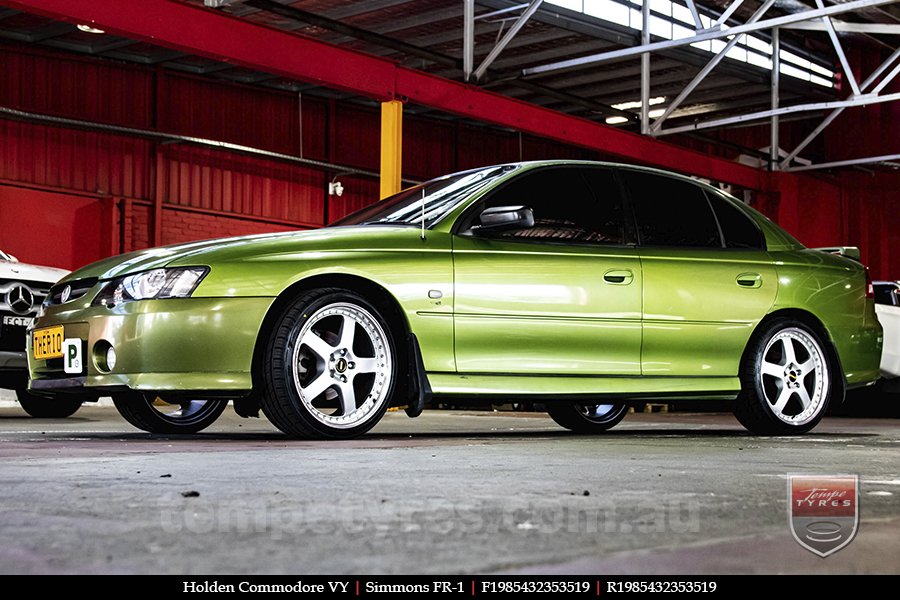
left=759, top=327, right=829, bottom=425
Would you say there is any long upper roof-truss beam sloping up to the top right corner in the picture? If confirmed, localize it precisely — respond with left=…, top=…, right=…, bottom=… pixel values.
left=522, top=0, right=896, bottom=76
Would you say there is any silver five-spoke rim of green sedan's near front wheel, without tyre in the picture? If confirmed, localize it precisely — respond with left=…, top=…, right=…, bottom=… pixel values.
left=292, top=302, right=393, bottom=429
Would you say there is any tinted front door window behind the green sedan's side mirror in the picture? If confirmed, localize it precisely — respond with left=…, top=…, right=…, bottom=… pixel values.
left=474, top=167, right=625, bottom=244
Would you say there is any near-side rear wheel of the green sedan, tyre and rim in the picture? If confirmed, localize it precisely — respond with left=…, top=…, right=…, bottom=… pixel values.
left=734, top=319, right=835, bottom=435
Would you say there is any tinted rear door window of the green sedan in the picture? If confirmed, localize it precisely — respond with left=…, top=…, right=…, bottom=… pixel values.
left=622, top=170, right=722, bottom=247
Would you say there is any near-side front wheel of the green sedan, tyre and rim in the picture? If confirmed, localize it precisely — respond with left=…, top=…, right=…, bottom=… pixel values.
left=261, top=288, right=401, bottom=439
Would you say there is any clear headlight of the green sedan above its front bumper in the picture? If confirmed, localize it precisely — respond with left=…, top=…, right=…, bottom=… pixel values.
left=91, top=267, right=209, bottom=306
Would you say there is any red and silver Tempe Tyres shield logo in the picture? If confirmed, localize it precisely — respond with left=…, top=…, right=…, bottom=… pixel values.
left=788, top=475, right=859, bottom=558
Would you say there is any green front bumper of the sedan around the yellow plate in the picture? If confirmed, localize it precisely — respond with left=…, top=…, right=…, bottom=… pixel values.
left=26, top=296, right=274, bottom=393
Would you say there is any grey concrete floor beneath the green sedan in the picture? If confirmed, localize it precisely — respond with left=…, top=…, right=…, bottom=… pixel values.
left=0, top=396, right=900, bottom=574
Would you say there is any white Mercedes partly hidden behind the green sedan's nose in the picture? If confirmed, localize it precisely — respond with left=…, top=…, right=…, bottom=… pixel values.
left=0, top=250, right=84, bottom=417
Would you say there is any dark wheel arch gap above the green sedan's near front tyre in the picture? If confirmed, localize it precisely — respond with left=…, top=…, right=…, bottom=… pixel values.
left=251, top=273, right=411, bottom=390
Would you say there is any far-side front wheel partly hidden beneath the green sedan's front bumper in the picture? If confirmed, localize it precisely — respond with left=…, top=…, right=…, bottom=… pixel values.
left=113, top=392, right=228, bottom=434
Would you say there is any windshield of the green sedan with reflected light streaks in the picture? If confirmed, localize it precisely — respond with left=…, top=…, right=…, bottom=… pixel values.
left=329, top=165, right=517, bottom=227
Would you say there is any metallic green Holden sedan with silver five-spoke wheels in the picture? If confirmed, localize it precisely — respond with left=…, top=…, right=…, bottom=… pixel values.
left=28, top=161, right=882, bottom=438
